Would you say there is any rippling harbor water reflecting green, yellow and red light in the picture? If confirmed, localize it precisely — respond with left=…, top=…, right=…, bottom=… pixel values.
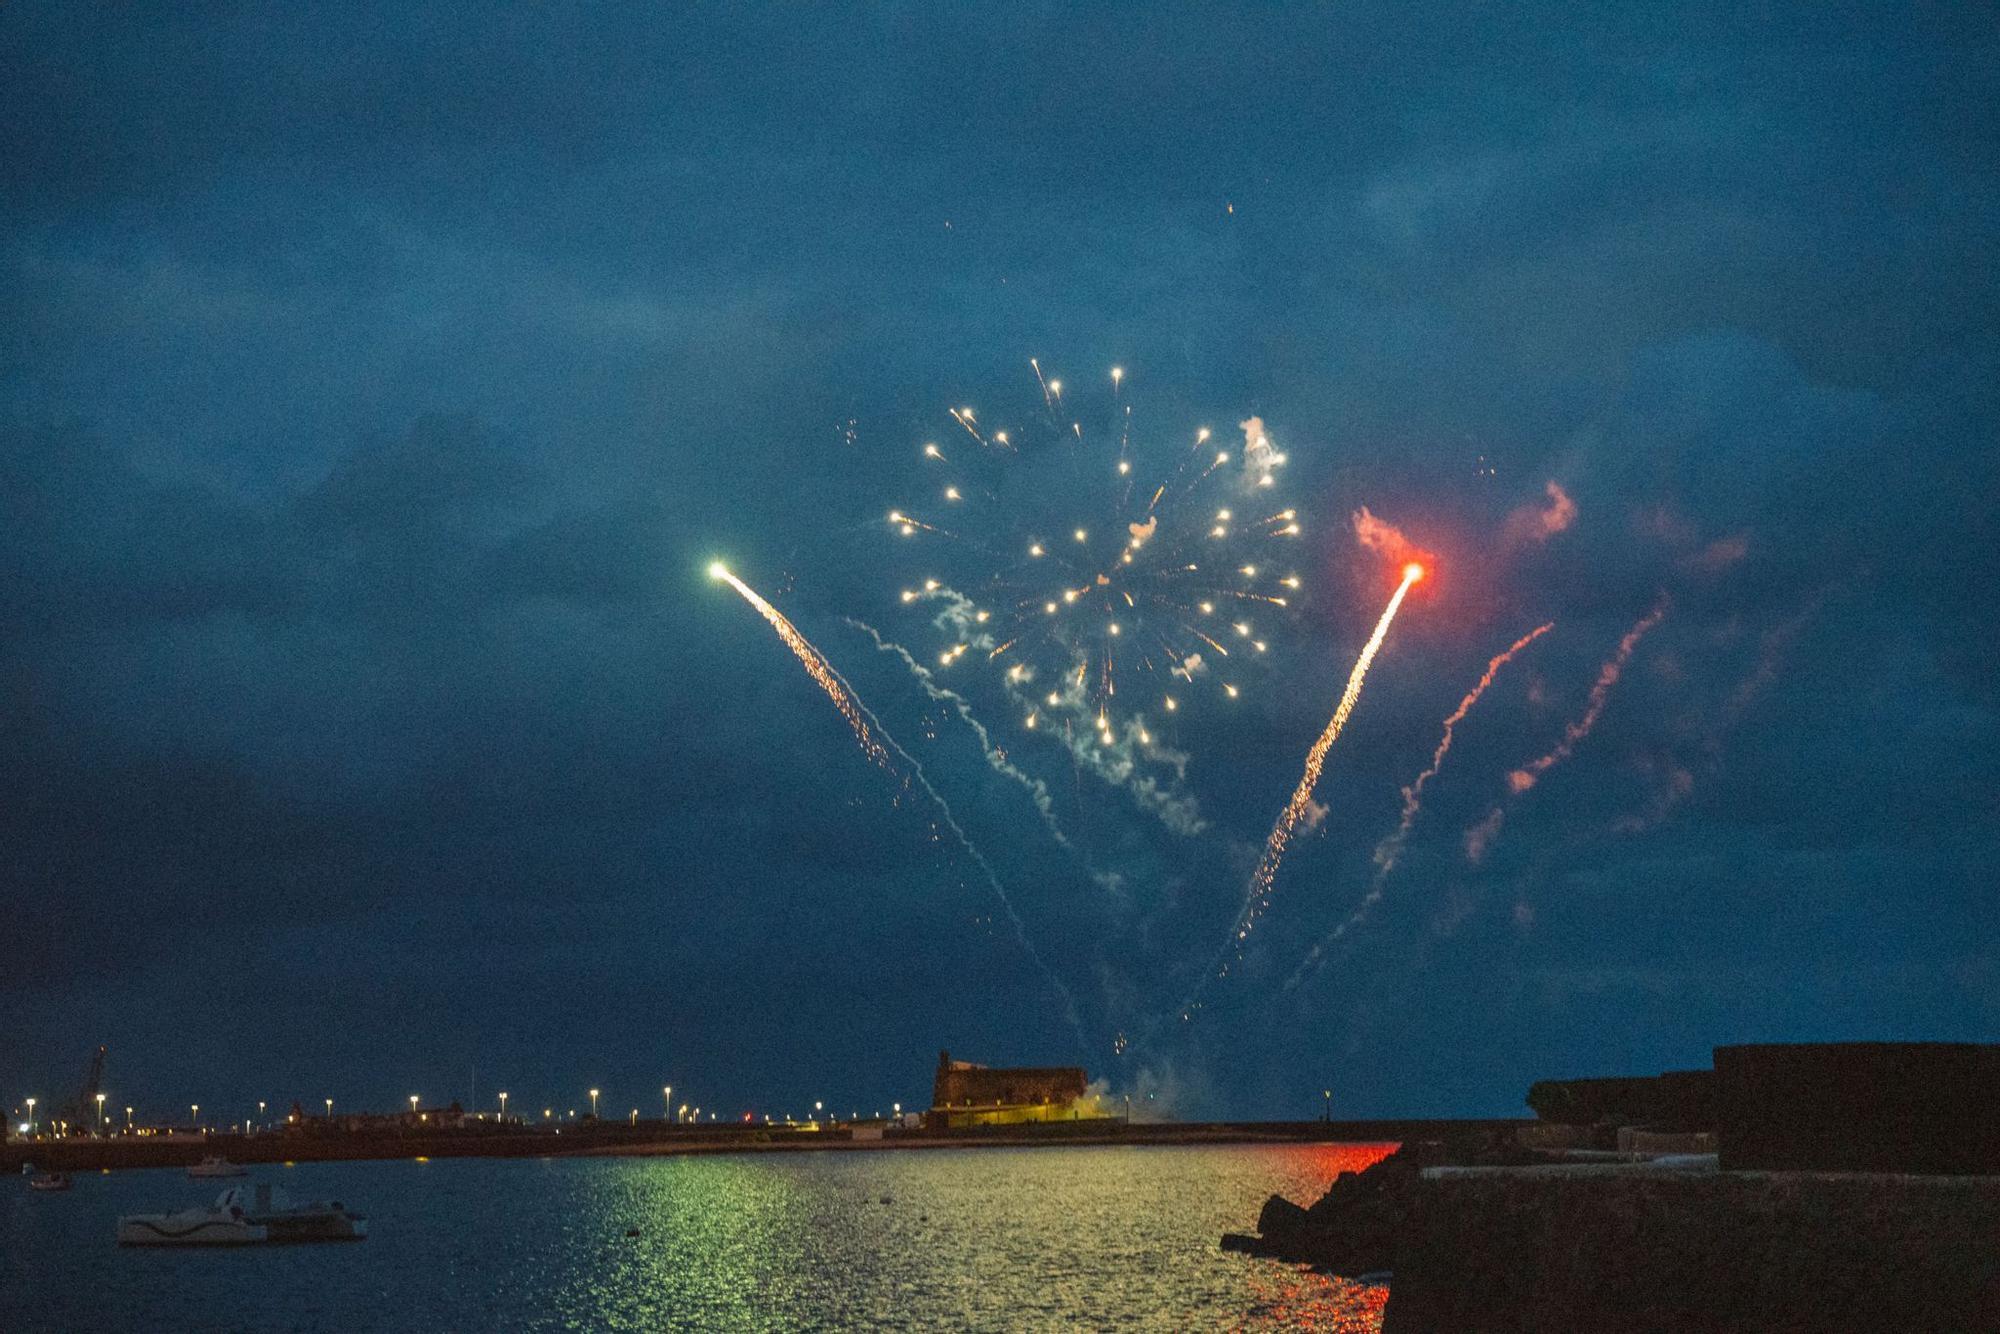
left=0, top=1144, right=1390, bottom=1334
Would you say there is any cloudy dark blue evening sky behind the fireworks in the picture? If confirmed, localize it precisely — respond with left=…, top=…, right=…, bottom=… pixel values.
left=0, top=4, right=2000, bottom=1116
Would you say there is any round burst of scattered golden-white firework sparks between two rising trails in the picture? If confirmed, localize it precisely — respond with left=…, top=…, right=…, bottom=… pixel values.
left=886, top=362, right=1304, bottom=752
